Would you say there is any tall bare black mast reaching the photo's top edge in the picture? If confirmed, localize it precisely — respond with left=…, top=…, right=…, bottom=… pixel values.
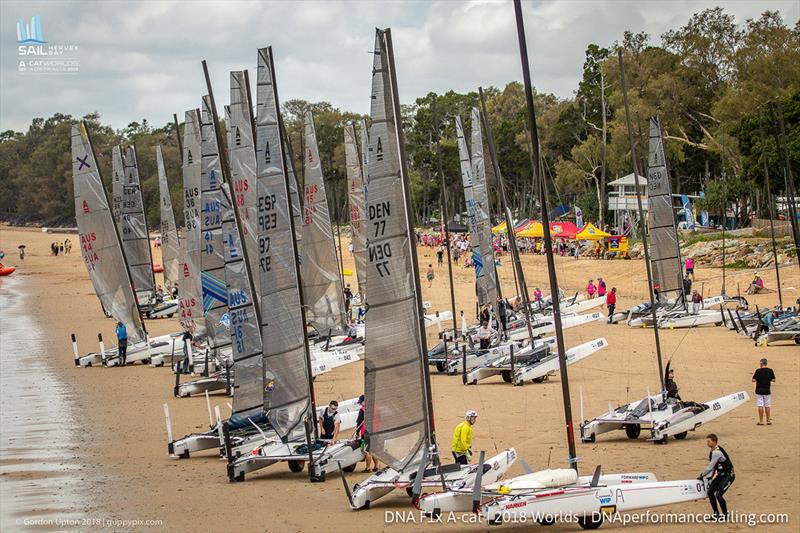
left=514, top=0, right=578, bottom=471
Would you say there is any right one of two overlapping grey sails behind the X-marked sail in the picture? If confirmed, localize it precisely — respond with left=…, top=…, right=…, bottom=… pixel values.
left=120, top=146, right=156, bottom=304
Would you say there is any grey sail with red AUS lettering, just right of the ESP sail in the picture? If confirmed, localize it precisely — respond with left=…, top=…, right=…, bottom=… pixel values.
left=301, top=111, right=347, bottom=335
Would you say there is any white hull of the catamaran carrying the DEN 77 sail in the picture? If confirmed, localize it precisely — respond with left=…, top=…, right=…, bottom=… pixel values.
left=350, top=448, right=517, bottom=510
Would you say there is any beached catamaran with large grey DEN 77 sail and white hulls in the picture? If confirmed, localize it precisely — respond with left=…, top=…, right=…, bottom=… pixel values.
left=336, top=29, right=514, bottom=509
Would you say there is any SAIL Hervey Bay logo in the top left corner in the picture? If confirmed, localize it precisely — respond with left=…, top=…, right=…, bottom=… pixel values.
left=16, top=15, right=78, bottom=74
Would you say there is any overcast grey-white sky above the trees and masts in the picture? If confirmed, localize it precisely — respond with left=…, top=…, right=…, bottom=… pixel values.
left=0, top=0, right=800, bottom=131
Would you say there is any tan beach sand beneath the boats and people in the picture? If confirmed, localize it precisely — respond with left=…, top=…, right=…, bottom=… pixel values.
left=0, top=227, right=800, bottom=532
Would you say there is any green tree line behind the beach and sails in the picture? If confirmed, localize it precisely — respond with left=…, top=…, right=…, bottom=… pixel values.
left=0, top=7, right=800, bottom=227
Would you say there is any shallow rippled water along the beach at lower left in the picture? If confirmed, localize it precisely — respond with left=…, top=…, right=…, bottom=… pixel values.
left=0, top=278, right=85, bottom=531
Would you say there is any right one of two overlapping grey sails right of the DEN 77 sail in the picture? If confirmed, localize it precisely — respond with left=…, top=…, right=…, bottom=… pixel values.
left=470, top=107, right=497, bottom=306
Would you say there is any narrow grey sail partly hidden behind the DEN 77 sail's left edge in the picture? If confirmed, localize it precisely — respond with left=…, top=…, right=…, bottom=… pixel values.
left=344, top=122, right=367, bottom=298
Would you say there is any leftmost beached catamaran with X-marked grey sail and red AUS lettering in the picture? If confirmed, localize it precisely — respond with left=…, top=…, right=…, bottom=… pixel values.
left=71, top=122, right=177, bottom=366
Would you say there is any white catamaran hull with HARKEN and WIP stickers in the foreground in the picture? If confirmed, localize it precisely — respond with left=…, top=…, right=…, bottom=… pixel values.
left=482, top=479, right=708, bottom=529
